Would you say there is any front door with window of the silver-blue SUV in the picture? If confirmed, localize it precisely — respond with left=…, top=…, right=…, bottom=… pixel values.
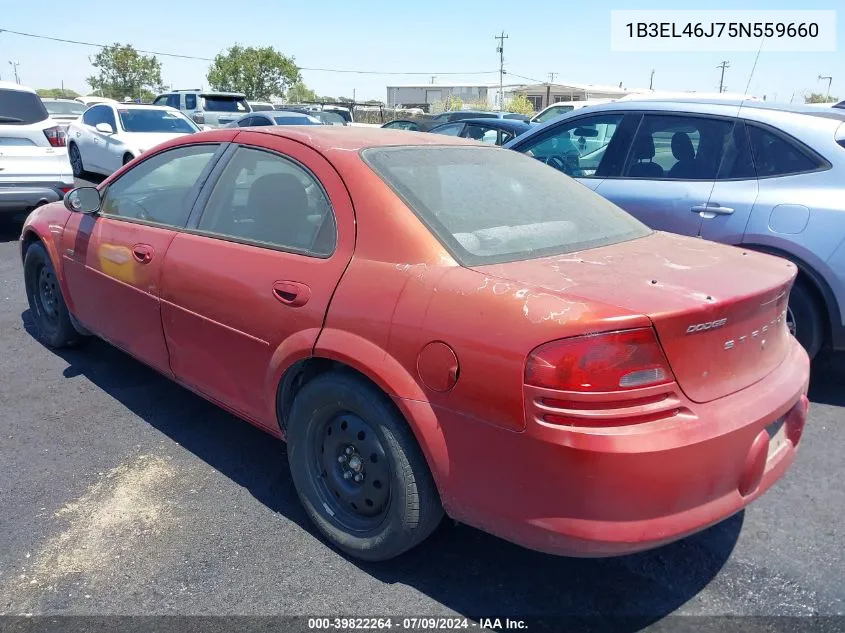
left=511, top=112, right=639, bottom=190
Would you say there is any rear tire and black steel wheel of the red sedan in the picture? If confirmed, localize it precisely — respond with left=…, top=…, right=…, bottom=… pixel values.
left=287, top=371, right=443, bottom=561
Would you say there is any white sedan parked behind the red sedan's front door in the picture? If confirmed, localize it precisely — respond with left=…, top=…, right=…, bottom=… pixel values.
left=67, top=103, right=200, bottom=178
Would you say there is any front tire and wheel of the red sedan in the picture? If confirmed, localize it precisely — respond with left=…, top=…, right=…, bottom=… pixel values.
left=23, top=243, right=85, bottom=348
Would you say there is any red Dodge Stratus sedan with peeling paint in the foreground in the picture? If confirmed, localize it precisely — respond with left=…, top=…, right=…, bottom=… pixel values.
left=21, top=126, right=809, bottom=560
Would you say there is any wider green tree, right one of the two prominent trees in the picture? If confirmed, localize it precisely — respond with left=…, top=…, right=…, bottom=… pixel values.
left=207, top=44, right=302, bottom=101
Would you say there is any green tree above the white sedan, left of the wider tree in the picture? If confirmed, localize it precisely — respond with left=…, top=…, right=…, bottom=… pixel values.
left=88, top=43, right=161, bottom=100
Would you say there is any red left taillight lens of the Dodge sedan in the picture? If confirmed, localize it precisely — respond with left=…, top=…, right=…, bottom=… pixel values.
left=525, top=328, right=674, bottom=392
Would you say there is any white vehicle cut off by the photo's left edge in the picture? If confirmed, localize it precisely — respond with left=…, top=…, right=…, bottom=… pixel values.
left=0, top=81, right=73, bottom=215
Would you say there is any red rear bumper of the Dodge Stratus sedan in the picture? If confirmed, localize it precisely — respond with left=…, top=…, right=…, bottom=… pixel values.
left=403, top=339, right=809, bottom=557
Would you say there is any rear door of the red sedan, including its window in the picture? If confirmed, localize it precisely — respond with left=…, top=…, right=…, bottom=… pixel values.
left=162, top=131, right=355, bottom=427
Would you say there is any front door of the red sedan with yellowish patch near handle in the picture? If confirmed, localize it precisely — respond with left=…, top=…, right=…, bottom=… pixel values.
left=62, top=143, right=226, bottom=374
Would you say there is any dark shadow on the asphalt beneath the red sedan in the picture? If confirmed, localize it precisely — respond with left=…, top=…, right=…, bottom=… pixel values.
left=22, top=311, right=744, bottom=632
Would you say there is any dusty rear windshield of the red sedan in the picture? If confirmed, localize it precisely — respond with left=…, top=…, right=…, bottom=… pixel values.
left=362, top=146, right=650, bottom=266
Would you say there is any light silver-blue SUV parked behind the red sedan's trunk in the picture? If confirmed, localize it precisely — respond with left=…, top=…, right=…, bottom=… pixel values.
left=505, top=100, right=845, bottom=356
